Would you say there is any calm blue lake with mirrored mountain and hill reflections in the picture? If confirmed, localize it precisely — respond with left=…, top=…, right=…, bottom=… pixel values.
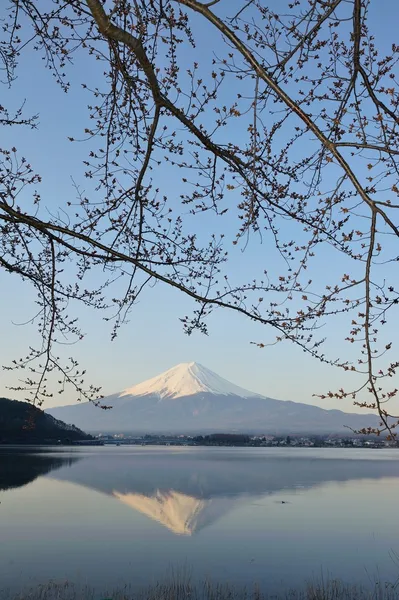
left=0, top=446, right=399, bottom=592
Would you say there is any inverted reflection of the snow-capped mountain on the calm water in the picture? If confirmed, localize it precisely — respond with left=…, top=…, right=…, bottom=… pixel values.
left=36, top=448, right=398, bottom=535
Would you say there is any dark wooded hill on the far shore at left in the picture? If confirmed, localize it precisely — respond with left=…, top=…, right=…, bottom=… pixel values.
left=0, top=398, right=91, bottom=444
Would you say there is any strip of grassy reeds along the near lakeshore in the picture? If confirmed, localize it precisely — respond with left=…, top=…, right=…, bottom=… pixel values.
left=0, top=579, right=399, bottom=600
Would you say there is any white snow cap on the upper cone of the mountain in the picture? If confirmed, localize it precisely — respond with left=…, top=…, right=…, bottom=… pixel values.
left=120, top=362, right=260, bottom=398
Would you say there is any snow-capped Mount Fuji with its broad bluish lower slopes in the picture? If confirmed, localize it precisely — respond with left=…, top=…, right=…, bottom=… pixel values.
left=47, top=362, right=377, bottom=434
